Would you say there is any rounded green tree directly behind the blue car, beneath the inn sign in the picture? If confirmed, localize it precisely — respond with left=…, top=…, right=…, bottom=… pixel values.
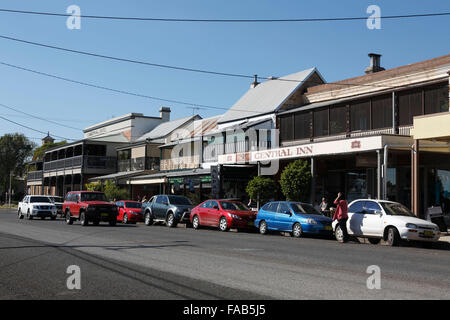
left=280, top=159, right=311, bottom=202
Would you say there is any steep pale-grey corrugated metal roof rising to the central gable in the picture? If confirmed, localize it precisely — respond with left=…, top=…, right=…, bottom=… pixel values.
left=219, top=68, right=317, bottom=123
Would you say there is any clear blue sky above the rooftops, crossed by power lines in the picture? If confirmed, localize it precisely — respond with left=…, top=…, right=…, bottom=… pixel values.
left=0, top=0, right=450, bottom=139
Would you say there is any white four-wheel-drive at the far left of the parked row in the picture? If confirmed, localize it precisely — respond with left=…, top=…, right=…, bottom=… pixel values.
left=17, top=196, right=57, bottom=220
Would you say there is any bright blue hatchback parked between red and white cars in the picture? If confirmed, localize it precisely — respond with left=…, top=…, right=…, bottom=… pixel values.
left=255, top=201, right=333, bottom=238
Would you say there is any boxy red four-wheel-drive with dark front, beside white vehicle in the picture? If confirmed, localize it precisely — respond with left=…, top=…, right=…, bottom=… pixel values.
left=63, top=191, right=118, bottom=226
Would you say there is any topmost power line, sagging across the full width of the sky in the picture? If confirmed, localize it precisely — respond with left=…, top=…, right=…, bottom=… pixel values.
left=0, top=9, right=450, bottom=23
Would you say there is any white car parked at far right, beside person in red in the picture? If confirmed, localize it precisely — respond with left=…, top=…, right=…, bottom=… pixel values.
left=332, top=199, right=441, bottom=246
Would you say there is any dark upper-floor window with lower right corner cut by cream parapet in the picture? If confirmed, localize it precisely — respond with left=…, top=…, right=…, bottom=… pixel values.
left=398, top=89, right=422, bottom=126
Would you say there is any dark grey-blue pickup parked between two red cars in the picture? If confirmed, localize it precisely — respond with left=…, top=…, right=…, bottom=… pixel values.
left=142, top=194, right=194, bottom=227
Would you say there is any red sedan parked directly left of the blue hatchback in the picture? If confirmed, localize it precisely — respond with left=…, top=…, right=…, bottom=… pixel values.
left=190, top=200, right=256, bottom=231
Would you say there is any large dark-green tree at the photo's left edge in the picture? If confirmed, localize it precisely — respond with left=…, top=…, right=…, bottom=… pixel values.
left=0, top=133, right=35, bottom=199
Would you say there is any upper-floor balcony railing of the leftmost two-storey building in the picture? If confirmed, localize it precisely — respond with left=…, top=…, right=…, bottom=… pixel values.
left=44, top=156, right=116, bottom=171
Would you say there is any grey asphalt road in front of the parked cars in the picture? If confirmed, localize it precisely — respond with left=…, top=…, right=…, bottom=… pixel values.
left=0, top=210, right=450, bottom=300
